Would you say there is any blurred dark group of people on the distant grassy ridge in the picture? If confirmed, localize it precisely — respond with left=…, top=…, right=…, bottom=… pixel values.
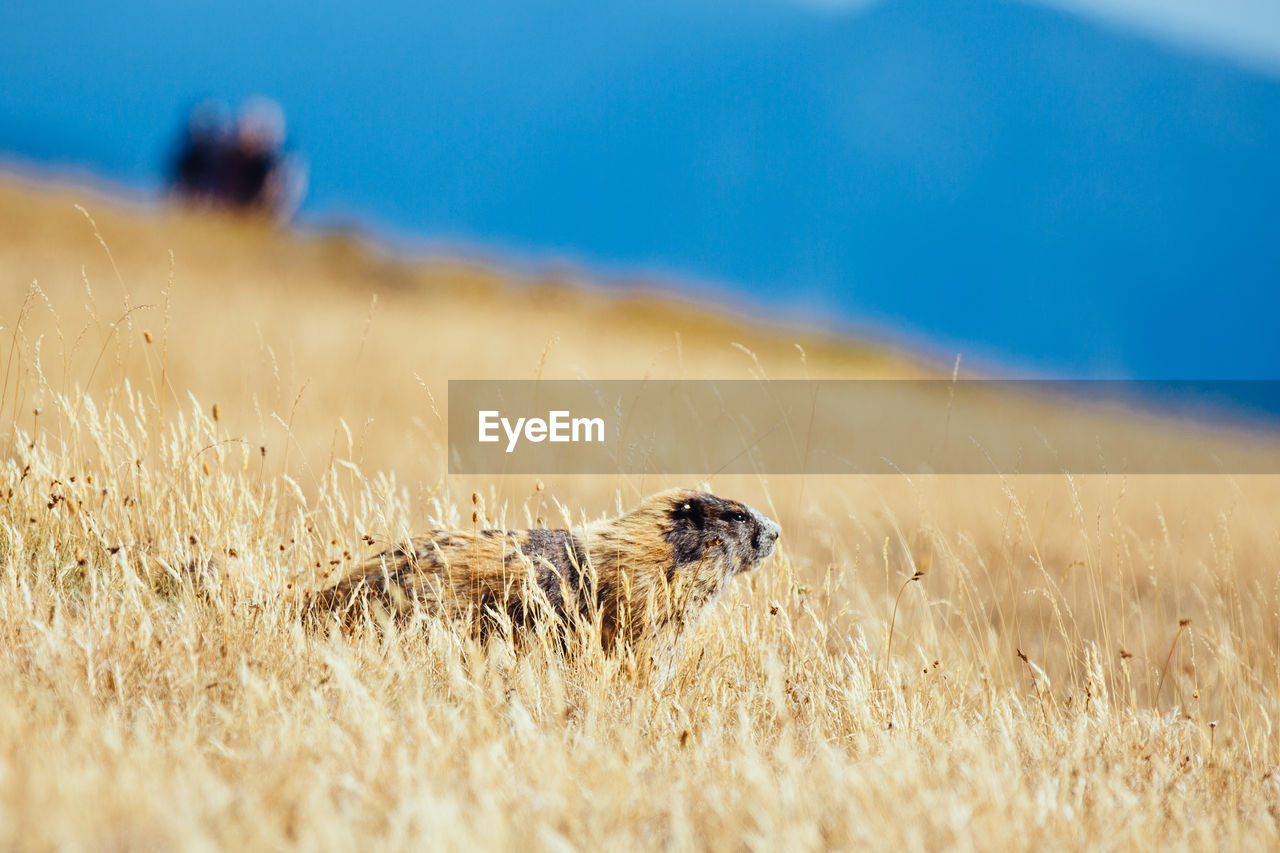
left=173, top=97, right=306, bottom=222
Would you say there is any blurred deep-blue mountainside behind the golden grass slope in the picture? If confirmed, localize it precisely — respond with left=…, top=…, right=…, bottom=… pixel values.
left=0, top=0, right=1280, bottom=379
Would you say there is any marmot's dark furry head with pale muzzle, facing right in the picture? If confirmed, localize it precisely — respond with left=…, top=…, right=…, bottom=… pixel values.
left=644, top=489, right=782, bottom=576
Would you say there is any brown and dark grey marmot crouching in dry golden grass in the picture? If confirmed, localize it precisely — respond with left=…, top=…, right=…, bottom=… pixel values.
left=306, top=489, right=781, bottom=649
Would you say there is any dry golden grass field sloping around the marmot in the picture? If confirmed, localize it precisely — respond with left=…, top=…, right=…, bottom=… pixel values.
left=0, top=179, right=1280, bottom=850
